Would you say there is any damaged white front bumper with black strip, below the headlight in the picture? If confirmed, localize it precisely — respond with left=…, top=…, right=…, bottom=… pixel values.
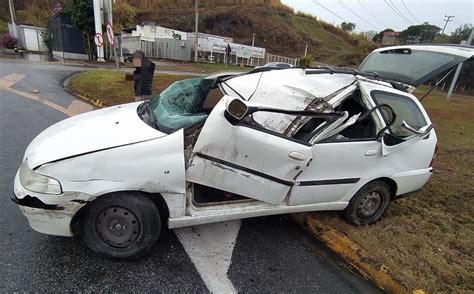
left=12, top=174, right=85, bottom=236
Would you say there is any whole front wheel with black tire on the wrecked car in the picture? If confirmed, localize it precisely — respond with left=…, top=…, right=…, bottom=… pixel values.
left=76, top=193, right=161, bottom=259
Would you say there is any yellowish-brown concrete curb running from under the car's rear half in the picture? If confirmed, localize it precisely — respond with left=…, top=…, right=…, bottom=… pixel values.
left=291, top=213, right=425, bottom=294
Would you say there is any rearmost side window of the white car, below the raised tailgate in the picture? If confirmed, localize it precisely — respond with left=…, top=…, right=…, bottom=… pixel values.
left=370, top=91, right=427, bottom=138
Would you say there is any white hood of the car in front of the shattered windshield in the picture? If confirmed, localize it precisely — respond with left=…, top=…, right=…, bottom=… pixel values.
left=24, top=102, right=166, bottom=169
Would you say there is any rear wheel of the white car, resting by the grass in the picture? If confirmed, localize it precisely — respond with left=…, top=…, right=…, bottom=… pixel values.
left=343, top=181, right=391, bottom=226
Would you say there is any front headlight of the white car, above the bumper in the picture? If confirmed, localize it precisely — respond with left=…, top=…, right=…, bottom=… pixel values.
left=19, top=161, right=62, bottom=195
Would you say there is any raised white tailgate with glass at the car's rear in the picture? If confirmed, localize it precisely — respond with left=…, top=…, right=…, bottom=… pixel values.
left=359, top=45, right=474, bottom=88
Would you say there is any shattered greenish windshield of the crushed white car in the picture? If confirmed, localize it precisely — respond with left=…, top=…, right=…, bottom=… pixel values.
left=149, top=78, right=216, bottom=130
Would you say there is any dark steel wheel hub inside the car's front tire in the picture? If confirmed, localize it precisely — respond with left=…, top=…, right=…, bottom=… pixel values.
left=96, top=206, right=141, bottom=248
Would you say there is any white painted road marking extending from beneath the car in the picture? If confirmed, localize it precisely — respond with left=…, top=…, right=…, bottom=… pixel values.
left=174, top=220, right=241, bottom=293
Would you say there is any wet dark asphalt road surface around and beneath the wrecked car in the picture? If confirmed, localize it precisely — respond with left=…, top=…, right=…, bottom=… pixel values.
left=0, top=60, right=380, bottom=293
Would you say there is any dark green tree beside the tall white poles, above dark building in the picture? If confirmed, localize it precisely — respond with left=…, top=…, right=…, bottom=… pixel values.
left=65, top=0, right=95, bottom=60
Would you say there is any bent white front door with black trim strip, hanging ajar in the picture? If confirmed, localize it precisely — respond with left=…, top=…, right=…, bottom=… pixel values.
left=186, top=96, right=312, bottom=204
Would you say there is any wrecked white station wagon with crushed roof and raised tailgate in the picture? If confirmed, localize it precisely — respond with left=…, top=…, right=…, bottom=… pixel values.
left=14, top=46, right=473, bottom=258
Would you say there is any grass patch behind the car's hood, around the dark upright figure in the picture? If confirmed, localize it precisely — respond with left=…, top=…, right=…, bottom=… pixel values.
left=68, top=70, right=193, bottom=106
